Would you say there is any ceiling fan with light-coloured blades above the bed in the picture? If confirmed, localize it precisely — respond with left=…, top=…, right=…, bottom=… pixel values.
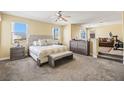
left=50, top=11, right=71, bottom=22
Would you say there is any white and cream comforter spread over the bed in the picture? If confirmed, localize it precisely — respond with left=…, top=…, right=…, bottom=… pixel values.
left=29, top=45, right=67, bottom=58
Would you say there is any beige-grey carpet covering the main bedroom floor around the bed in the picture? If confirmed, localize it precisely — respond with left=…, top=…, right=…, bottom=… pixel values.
left=0, top=54, right=124, bottom=81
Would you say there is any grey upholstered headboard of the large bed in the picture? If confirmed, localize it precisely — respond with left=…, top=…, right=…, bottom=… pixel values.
left=28, top=35, right=53, bottom=46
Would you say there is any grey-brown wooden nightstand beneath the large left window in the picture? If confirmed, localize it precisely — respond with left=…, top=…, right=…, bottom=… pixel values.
left=10, top=47, right=25, bottom=61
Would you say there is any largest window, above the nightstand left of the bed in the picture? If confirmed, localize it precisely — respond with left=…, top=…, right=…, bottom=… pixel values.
left=12, top=22, right=27, bottom=43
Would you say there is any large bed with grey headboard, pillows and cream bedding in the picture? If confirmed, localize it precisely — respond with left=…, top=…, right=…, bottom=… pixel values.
left=28, top=35, right=68, bottom=65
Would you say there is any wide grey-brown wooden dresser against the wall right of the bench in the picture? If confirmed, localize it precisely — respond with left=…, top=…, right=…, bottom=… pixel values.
left=70, top=40, right=90, bottom=56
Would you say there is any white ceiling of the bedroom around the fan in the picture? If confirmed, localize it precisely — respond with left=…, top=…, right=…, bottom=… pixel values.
left=3, top=11, right=122, bottom=25
